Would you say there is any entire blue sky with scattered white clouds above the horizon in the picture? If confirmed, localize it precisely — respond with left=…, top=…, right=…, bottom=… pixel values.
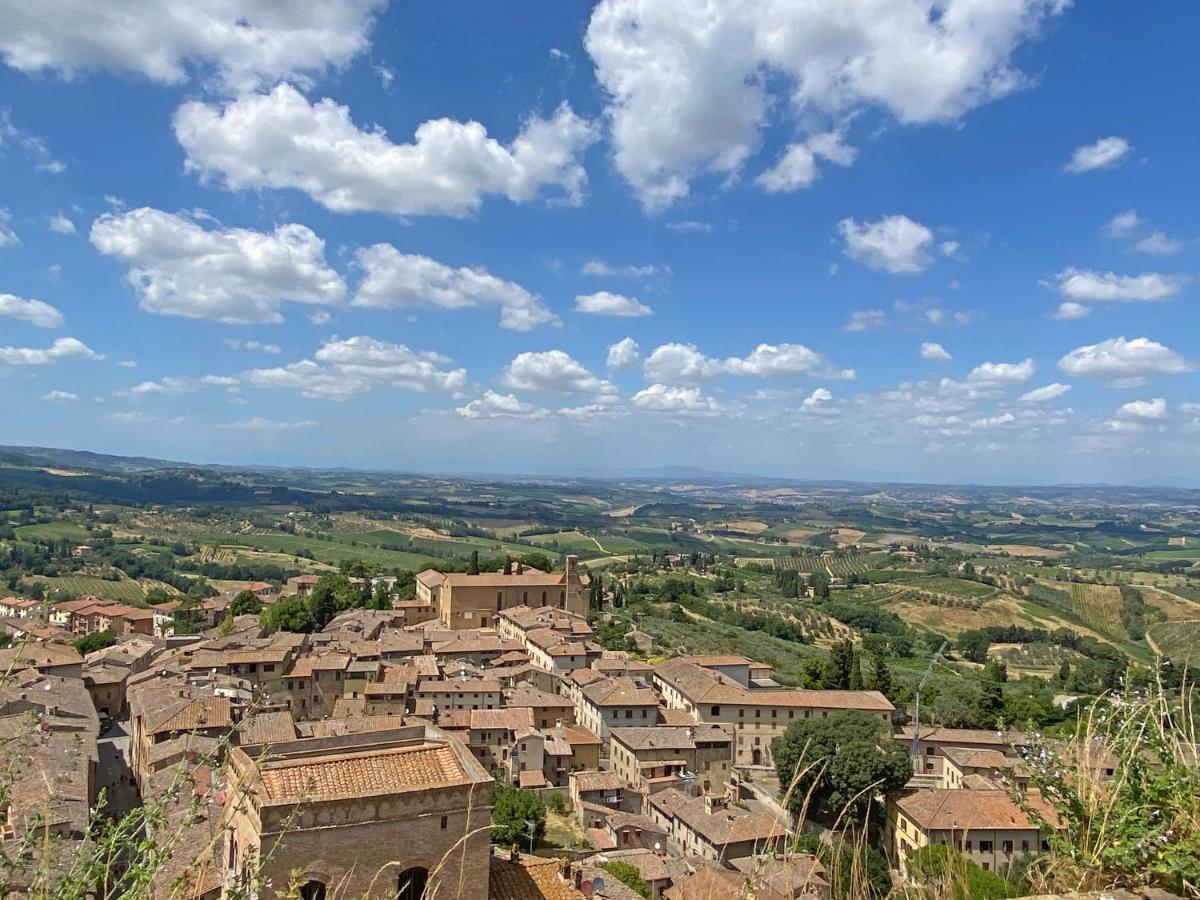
left=0, top=0, right=1200, bottom=484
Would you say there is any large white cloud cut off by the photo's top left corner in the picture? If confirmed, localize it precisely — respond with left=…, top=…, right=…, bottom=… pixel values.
left=0, top=0, right=383, bottom=91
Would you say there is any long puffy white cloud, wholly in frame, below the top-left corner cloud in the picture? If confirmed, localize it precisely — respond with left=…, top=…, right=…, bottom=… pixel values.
left=174, top=84, right=599, bottom=216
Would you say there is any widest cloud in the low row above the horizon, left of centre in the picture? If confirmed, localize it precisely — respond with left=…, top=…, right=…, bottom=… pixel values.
left=242, top=336, right=467, bottom=400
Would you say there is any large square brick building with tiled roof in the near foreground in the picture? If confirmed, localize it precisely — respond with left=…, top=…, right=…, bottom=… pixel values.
left=222, top=726, right=492, bottom=900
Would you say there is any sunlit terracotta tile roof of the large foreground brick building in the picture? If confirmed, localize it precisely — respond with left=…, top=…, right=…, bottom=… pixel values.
left=259, top=743, right=470, bottom=803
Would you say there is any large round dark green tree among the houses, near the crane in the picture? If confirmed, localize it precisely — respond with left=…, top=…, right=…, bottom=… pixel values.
left=772, top=710, right=912, bottom=822
